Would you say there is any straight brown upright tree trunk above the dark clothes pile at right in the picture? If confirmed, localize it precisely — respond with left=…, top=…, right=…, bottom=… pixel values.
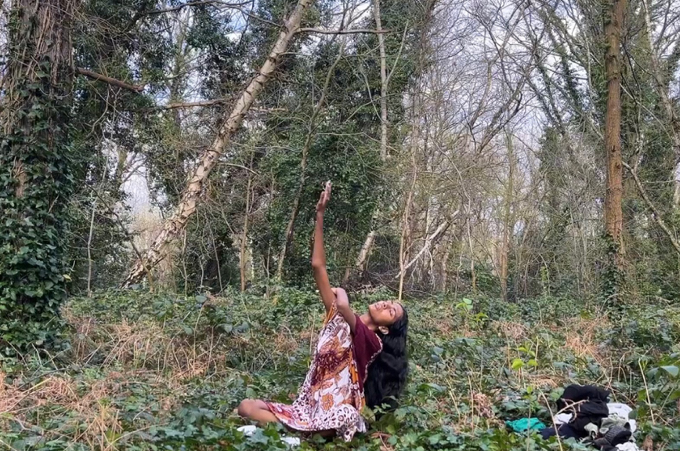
left=604, top=0, right=626, bottom=271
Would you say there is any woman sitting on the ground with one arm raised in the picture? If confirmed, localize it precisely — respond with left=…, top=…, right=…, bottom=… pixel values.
left=238, top=182, right=408, bottom=441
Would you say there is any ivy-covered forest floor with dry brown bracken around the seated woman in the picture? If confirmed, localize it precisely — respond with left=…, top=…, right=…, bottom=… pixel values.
left=0, top=289, right=680, bottom=451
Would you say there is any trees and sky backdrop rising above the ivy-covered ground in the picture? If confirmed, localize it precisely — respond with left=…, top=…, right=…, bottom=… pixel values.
left=0, top=0, right=680, bottom=342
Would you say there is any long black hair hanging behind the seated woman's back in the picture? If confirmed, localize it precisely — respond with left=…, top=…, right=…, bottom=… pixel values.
left=364, top=305, right=408, bottom=410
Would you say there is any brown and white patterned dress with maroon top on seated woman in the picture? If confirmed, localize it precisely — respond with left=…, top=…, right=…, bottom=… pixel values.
left=267, top=304, right=382, bottom=441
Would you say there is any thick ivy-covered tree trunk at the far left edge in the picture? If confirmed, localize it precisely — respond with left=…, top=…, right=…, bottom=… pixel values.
left=0, top=0, right=75, bottom=352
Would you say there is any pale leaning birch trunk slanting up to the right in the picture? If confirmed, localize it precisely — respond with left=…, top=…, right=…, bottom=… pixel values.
left=123, top=0, right=312, bottom=286
